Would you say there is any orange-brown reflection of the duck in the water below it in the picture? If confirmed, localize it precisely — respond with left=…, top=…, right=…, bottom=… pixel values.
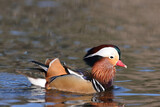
left=45, top=89, right=124, bottom=107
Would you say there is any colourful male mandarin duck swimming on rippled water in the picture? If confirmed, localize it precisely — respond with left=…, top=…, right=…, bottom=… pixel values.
left=28, top=45, right=127, bottom=94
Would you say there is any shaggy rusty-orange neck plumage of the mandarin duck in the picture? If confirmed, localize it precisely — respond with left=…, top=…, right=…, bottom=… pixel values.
left=92, top=58, right=116, bottom=87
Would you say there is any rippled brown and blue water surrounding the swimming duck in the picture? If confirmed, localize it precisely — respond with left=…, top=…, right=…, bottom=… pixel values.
left=0, top=0, right=160, bottom=107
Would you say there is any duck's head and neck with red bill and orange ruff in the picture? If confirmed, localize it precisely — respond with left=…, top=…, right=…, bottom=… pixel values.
left=84, top=45, right=127, bottom=84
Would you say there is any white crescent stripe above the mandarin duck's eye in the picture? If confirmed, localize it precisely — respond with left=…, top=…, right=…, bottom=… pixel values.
left=85, top=47, right=119, bottom=58
